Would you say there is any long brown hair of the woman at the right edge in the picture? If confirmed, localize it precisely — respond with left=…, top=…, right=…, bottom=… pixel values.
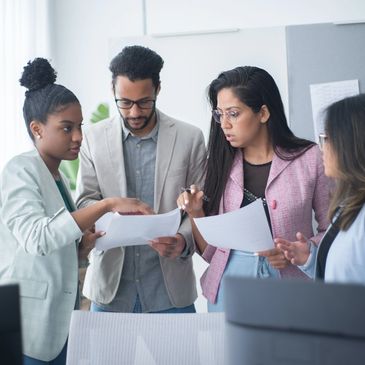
left=325, top=94, right=365, bottom=230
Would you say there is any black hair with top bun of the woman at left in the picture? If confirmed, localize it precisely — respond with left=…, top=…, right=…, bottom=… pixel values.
left=19, top=58, right=79, bottom=140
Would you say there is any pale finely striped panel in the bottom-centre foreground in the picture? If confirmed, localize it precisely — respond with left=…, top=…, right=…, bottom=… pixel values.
left=67, top=311, right=223, bottom=365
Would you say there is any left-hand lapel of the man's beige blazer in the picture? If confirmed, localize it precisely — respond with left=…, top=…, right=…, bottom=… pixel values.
left=104, top=116, right=127, bottom=197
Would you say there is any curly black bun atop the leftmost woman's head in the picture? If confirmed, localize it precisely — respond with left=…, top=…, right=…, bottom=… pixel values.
left=19, top=58, right=57, bottom=91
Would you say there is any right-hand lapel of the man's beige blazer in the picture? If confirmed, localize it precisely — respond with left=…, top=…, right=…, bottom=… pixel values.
left=154, top=111, right=176, bottom=212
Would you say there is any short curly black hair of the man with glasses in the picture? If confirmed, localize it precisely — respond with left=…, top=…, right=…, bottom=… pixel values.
left=109, top=46, right=163, bottom=89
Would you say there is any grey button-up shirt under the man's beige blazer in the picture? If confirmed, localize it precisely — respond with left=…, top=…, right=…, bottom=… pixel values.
left=97, top=118, right=172, bottom=312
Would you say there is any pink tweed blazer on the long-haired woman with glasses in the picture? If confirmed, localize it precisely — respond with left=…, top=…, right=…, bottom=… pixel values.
left=200, top=146, right=331, bottom=303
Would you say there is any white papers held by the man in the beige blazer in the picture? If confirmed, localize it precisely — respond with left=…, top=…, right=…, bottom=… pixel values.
left=95, top=208, right=181, bottom=251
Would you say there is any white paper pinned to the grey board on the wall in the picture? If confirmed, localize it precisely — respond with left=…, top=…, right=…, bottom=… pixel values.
left=309, top=80, right=360, bottom=142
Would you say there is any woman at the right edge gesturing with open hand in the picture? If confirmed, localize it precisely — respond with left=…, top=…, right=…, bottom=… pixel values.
left=278, top=94, right=365, bottom=284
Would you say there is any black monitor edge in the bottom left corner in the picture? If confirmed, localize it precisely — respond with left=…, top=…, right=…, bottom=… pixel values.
left=0, top=285, right=23, bottom=365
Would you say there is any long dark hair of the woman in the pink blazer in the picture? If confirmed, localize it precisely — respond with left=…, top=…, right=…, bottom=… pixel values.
left=204, top=66, right=314, bottom=214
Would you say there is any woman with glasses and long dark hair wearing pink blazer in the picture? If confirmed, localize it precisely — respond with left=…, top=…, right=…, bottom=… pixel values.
left=178, top=66, right=329, bottom=311
